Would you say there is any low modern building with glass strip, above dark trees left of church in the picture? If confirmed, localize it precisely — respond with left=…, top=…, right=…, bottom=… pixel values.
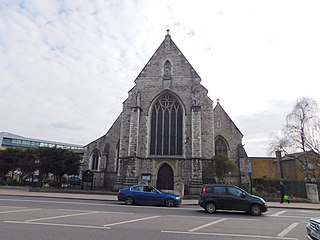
left=0, top=132, right=84, bottom=151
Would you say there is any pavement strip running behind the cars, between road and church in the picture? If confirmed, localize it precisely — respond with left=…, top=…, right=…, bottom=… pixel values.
left=0, top=186, right=320, bottom=210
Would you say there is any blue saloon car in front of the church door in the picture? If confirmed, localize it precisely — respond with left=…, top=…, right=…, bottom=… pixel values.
left=118, top=185, right=181, bottom=207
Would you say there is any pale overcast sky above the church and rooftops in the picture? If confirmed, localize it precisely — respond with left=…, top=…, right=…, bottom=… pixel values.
left=0, top=0, right=320, bottom=157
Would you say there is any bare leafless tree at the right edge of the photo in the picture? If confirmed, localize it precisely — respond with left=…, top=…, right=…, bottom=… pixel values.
left=271, top=98, right=320, bottom=180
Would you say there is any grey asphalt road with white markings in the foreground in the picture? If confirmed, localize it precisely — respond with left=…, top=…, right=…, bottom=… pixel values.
left=0, top=196, right=320, bottom=240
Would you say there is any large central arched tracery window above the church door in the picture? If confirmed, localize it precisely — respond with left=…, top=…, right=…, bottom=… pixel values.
left=150, top=93, right=183, bottom=155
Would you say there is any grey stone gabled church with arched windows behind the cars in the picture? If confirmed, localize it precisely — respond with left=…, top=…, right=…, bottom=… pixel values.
left=83, top=30, right=248, bottom=195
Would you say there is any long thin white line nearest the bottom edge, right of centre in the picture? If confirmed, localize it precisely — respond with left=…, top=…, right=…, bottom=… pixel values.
left=161, top=231, right=299, bottom=240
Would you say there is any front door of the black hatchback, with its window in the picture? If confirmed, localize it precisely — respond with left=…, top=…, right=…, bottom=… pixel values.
left=225, top=186, right=250, bottom=211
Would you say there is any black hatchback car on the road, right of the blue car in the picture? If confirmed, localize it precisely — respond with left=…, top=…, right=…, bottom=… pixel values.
left=199, top=184, right=268, bottom=216
